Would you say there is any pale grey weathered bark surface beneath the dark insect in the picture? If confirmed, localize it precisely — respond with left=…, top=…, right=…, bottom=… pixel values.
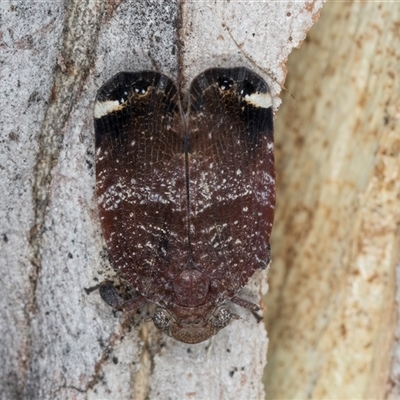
left=0, top=0, right=322, bottom=400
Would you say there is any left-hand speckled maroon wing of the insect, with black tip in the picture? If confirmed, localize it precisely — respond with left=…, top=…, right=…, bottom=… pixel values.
left=95, top=71, right=189, bottom=301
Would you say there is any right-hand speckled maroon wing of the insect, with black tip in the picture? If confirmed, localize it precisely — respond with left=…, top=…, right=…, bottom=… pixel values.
left=188, top=67, right=275, bottom=297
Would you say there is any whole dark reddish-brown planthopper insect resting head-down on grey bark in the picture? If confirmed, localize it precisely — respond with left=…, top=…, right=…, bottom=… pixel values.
left=94, top=67, right=275, bottom=343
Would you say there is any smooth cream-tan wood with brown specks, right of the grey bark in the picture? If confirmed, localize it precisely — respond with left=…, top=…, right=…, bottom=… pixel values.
left=265, top=2, right=400, bottom=399
